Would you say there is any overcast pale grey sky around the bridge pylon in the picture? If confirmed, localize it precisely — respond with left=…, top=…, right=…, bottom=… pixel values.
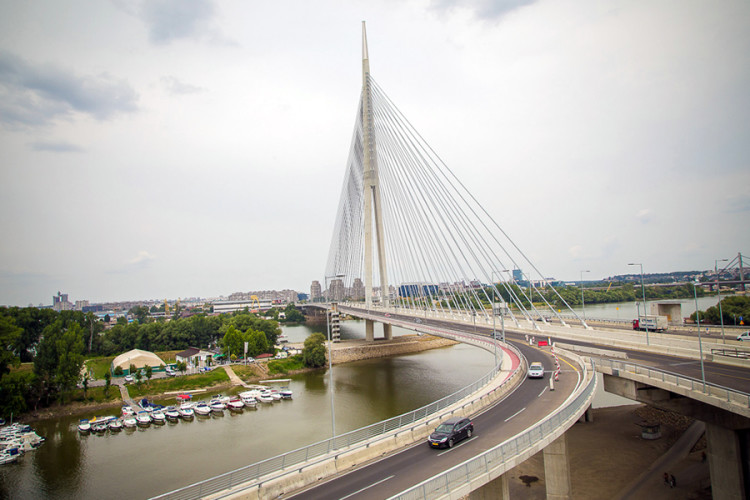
left=0, top=0, right=750, bottom=305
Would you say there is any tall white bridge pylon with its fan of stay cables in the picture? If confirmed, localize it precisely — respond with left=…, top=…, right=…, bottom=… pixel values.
left=326, top=21, right=586, bottom=339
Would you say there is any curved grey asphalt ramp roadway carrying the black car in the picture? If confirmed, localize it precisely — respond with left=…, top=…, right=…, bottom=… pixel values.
left=281, top=336, right=582, bottom=500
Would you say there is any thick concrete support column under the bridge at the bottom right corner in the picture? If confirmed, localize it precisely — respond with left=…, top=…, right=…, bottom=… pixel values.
left=706, top=423, right=748, bottom=500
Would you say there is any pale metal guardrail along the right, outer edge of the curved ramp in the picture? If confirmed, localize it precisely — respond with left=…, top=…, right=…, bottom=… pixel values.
left=388, top=363, right=596, bottom=500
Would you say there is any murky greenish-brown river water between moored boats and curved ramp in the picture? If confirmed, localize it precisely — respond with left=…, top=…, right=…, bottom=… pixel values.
left=0, top=321, right=494, bottom=499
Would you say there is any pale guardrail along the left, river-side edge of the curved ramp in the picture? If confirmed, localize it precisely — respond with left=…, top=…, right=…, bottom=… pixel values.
left=152, top=335, right=522, bottom=500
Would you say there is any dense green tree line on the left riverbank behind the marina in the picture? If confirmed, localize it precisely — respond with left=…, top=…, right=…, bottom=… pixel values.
left=0, top=305, right=304, bottom=417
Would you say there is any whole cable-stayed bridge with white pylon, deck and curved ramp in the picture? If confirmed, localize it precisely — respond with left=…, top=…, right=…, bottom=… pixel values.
left=154, top=23, right=750, bottom=500
